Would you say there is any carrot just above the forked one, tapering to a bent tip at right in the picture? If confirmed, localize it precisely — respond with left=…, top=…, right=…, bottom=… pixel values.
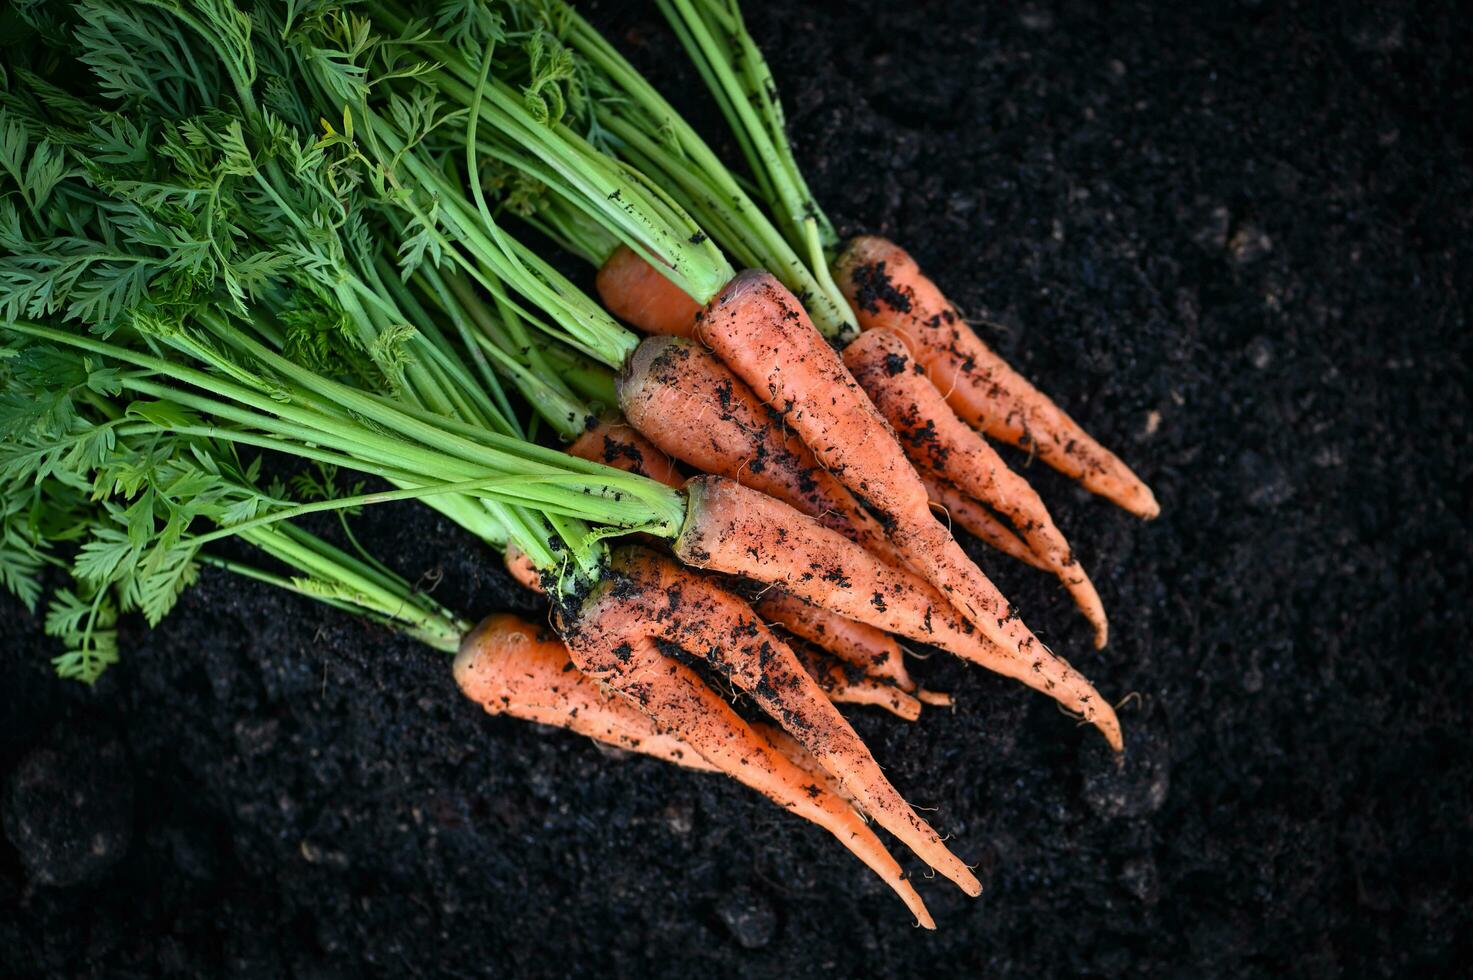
left=673, top=476, right=1122, bottom=752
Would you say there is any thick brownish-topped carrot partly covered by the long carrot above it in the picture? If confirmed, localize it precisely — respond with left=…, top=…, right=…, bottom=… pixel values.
left=616, top=337, right=900, bottom=561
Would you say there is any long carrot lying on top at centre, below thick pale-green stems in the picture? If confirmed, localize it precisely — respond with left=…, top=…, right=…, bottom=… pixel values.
left=697, top=270, right=1041, bottom=656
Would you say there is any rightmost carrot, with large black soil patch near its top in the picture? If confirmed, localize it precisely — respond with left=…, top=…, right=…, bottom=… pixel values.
left=834, top=236, right=1161, bottom=519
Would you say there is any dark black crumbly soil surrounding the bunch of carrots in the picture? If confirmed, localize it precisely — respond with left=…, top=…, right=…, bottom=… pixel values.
left=0, top=0, right=1473, bottom=977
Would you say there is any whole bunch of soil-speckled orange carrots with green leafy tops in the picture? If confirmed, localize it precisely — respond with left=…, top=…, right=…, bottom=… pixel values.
left=0, top=0, right=1158, bottom=928
